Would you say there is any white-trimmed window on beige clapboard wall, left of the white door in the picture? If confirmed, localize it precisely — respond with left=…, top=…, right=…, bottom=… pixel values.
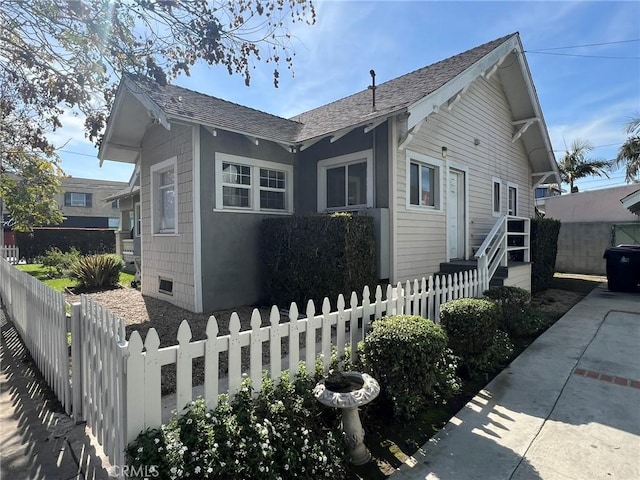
left=407, top=151, right=442, bottom=210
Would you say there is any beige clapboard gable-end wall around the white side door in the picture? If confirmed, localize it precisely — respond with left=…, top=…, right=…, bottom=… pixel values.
left=394, top=75, right=533, bottom=281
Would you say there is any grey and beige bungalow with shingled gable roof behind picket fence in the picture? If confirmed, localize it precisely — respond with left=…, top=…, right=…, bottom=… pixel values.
left=99, top=34, right=559, bottom=311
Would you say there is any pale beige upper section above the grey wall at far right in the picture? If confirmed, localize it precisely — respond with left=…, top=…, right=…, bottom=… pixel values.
left=545, top=185, right=640, bottom=222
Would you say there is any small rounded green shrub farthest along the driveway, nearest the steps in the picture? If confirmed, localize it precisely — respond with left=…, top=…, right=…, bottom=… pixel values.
left=484, top=286, right=531, bottom=337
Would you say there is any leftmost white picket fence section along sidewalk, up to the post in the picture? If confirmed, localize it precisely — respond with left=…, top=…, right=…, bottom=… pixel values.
left=0, top=258, right=71, bottom=414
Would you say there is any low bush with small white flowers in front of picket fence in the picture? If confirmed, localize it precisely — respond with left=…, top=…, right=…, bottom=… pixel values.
left=127, top=370, right=345, bottom=480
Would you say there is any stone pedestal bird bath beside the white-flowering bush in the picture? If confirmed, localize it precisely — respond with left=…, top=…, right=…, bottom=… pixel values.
left=313, top=372, right=380, bottom=465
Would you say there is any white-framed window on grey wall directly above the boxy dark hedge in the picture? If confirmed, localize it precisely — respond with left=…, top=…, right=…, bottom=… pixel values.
left=318, top=150, right=373, bottom=211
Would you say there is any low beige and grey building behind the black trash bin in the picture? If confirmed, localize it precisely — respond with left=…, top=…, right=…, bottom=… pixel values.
left=545, top=185, right=640, bottom=275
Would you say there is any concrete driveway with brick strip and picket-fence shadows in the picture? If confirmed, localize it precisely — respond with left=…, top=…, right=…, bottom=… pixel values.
left=393, top=285, right=640, bottom=480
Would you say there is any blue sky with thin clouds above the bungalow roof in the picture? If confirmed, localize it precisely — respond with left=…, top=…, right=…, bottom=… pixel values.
left=53, top=1, right=640, bottom=191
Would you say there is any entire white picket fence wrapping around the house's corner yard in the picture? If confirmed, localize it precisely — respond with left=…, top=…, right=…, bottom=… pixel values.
left=0, top=259, right=488, bottom=474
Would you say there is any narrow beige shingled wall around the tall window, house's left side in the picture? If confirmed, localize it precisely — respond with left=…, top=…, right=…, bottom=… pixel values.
left=140, top=124, right=195, bottom=312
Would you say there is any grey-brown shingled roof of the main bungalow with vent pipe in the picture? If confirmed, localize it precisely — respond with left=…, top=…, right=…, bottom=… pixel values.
left=129, top=34, right=515, bottom=144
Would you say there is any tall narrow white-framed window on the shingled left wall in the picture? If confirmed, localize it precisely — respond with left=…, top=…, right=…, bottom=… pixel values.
left=151, top=157, right=178, bottom=234
